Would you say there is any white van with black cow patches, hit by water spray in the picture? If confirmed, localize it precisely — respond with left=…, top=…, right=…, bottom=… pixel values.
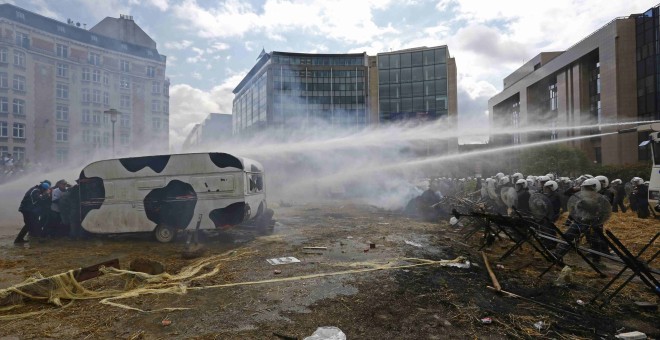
left=78, top=152, right=272, bottom=242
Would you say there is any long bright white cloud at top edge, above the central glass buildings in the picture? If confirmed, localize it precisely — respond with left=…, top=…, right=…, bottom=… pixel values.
left=173, top=0, right=396, bottom=43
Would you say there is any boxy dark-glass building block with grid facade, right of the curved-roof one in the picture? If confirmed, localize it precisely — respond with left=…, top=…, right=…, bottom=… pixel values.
left=378, top=46, right=450, bottom=122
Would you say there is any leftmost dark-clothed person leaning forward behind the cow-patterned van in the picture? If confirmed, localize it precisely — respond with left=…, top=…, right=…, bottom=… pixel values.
left=14, top=182, right=50, bottom=243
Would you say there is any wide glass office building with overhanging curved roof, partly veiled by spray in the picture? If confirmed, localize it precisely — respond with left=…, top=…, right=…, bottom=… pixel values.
left=232, top=52, right=368, bottom=135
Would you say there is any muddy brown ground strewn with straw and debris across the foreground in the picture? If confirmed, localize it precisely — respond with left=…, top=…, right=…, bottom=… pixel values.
left=0, top=202, right=660, bottom=339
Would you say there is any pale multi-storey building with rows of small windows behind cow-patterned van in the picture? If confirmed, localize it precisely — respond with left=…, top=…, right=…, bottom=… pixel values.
left=0, top=4, right=169, bottom=163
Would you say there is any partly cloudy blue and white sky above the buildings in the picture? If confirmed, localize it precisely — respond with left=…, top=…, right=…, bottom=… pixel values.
left=9, top=0, right=658, bottom=147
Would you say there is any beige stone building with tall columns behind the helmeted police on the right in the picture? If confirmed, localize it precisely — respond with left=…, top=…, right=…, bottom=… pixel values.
left=488, top=15, right=640, bottom=164
